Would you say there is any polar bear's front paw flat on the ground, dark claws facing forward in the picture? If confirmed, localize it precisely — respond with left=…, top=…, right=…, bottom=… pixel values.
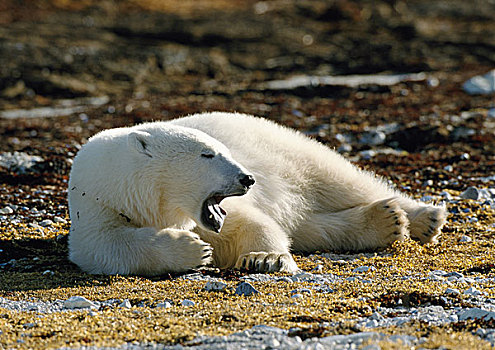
left=234, top=252, right=299, bottom=272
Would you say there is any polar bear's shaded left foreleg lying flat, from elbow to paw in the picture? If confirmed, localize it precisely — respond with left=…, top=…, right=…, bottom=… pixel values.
left=69, top=226, right=212, bottom=275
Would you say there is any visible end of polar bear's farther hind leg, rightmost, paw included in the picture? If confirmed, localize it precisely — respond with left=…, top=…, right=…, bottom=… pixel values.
left=399, top=198, right=447, bottom=243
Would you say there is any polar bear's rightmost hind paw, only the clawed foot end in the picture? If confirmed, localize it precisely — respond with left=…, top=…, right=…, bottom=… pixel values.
left=409, top=205, right=447, bottom=243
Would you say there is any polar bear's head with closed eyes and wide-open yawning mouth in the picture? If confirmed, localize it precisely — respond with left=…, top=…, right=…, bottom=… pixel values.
left=127, top=123, right=255, bottom=233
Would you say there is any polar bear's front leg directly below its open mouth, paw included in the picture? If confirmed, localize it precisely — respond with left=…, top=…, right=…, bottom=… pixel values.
left=198, top=204, right=299, bottom=272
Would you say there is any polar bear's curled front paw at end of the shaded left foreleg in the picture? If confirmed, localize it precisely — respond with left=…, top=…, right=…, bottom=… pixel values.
left=175, top=233, right=213, bottom=269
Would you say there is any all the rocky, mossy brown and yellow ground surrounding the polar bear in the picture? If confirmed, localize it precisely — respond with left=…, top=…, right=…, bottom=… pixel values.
left=0, top=0, right=495, bottom=349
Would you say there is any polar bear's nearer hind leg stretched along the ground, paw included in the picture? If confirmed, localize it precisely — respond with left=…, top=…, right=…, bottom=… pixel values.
left=293, top=197, right=409, bottom=252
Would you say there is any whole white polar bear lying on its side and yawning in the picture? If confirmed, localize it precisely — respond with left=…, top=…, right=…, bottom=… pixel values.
left=68, top=112, right=446, bottom=275
